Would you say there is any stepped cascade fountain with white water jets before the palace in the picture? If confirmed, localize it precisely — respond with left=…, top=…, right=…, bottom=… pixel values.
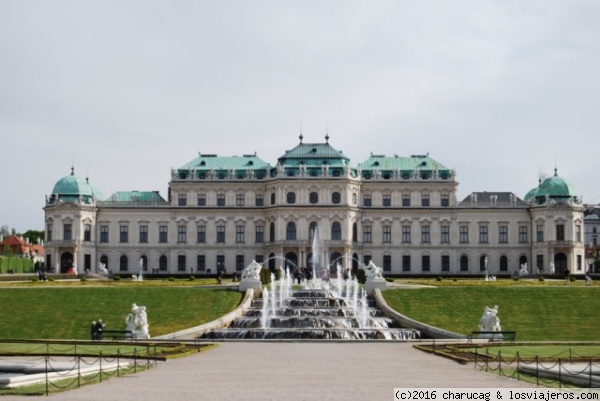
left=202, top=223, right=420, bottom=340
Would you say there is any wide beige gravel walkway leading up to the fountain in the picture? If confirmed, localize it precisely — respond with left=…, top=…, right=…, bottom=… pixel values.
left=9, top=342, right=531, bottom=401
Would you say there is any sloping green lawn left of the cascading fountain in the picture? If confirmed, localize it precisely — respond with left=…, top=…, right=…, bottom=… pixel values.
left=0, top=282, right=242, bottom=339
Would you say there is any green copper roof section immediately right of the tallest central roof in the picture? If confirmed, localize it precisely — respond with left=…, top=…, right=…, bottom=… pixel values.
left=358, top=155, right=452, bottom=178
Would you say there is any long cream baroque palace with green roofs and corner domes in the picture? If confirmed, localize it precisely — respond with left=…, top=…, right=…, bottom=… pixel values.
left=44, top=135, right=585, bottom=276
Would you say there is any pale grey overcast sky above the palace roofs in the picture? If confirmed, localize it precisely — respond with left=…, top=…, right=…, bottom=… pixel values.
left=0, top=0, right=600, bottom=232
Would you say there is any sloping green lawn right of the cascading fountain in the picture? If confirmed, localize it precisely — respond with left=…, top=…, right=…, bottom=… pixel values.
left=383, top=280, right=600, bottom=341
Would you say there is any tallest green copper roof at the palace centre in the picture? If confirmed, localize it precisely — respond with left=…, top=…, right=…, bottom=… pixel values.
left=277, top=136, right=350, bottom=167
